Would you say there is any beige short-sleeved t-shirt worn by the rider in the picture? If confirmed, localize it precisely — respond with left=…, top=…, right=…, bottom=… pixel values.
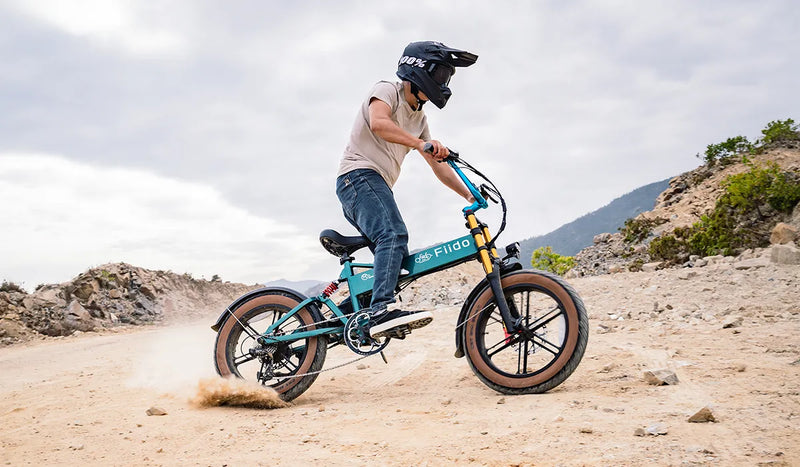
left=336, top=81, right=431, bottom=188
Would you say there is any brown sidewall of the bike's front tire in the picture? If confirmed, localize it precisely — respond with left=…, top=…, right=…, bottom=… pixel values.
left=464, top=271, right=588, bottom=392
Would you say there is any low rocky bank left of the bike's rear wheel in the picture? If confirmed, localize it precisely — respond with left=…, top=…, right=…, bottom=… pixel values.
left=0, top=263, right=256, bottom=344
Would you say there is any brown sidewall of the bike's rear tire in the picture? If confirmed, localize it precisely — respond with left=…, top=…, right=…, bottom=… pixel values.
left=214, top=294, right=327, bottom=400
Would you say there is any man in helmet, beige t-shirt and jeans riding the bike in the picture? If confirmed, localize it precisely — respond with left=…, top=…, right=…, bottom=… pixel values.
left=336, top=41, right=478, bottom=338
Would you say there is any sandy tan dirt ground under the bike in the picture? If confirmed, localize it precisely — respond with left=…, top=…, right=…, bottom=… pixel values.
left=0, top=268, right=800, bottom=465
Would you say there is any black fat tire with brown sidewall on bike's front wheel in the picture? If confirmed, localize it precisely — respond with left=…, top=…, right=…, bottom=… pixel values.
left=462, top=270, right=589, bottom=395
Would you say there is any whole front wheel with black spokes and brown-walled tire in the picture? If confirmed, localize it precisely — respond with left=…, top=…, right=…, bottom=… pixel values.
left=463, top=271, right=589, bottom=394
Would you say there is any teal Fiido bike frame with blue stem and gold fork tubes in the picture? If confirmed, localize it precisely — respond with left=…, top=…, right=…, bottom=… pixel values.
left=258, top=157, right=499, bottom=345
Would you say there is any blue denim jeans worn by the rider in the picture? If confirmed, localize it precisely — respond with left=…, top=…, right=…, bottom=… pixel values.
left=336, top=169, right=408, bottom=310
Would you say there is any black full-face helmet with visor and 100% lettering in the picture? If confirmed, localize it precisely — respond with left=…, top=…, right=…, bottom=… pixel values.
left=397, top=41, right=478, bottom=109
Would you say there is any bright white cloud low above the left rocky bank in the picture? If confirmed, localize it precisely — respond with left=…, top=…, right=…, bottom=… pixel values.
left=0, top=154, right=324, bottom=289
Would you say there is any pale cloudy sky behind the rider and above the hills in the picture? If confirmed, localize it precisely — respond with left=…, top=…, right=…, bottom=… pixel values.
left=0, top=0, right=800, bottom=290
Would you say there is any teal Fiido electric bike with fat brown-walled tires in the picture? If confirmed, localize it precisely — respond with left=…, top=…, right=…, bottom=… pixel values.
left=211, top=150, right=589, bottom=401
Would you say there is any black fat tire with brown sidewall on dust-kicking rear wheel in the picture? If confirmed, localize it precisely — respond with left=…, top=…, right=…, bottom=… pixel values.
left=214, top=290, right=328, bottom=402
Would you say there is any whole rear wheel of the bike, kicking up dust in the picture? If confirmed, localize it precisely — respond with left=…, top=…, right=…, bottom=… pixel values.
left=214, top=291, right=327, bottom=401
